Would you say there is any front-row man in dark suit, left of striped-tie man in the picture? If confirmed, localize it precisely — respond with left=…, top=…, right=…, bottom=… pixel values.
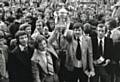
left=8, top=31, right=33, bottom=82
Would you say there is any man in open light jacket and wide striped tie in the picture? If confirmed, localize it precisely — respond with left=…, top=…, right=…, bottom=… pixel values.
left=31, top=35, right=59, bottom=82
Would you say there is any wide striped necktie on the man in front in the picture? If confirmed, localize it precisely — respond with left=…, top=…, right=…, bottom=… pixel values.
left=46, top=53, right=54, bottom=75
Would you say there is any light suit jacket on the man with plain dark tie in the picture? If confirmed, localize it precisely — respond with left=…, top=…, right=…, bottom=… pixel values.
left=65, top=31, right=94, bottom=71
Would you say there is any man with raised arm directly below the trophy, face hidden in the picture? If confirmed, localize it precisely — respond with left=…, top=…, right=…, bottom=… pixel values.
left=48, top=24, right=66, bottom=82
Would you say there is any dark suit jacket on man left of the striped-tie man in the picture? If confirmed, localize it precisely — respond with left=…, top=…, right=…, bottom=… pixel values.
left=8, top=46, right=33, bottom=82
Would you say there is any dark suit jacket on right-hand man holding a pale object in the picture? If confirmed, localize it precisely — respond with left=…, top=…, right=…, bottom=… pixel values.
left=92, top=37, right=114, bottom=72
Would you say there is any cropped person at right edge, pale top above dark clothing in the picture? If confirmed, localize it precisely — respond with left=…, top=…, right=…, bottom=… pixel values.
left=110, top=27, right=120, bottom=82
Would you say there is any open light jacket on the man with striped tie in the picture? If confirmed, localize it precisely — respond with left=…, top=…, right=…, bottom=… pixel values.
left=31, top=47, right=58, bottom=82
